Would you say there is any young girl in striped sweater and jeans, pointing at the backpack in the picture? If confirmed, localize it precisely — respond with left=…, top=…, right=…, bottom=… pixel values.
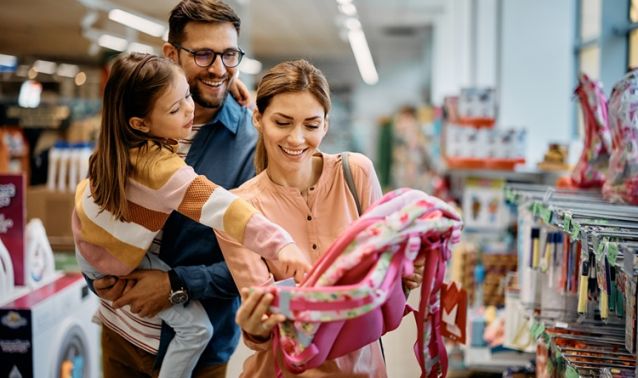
left=72, top=53, right=310, bottom=377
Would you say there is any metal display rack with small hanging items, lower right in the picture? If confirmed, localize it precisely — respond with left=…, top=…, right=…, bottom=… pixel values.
left=505, top=184, right=638, bottom=377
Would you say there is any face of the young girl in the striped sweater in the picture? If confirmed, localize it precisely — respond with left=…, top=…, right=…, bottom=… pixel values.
left=143, top=71, right=195, bottom=140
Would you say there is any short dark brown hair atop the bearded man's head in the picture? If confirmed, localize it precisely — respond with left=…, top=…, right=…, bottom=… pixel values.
left=168, top=0, right=241, bottom=44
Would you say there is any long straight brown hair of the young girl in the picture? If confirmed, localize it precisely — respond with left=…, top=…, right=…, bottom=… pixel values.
left=89, top=53, right=179, bottom=220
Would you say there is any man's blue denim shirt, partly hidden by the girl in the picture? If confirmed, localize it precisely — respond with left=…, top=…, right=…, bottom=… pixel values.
left=157, top=95, right=257, bottom=365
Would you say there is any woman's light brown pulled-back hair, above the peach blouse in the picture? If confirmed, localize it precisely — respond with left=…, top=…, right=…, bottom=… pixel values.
left=255, top=59, right=331, bottom=173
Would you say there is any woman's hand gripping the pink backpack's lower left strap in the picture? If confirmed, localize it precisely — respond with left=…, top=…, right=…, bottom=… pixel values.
left=235, top=288, right=286, bottom=339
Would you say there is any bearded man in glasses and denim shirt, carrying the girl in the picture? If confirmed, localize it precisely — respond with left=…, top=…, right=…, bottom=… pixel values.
left=93, top=0, right=257, bottom=378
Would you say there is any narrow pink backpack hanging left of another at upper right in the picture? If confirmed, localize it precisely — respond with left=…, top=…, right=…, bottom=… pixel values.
left=571, top=73, right=611, bottom=188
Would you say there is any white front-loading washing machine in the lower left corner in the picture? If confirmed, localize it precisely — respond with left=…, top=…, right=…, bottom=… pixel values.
left=0, top=273, right=100, bottom=378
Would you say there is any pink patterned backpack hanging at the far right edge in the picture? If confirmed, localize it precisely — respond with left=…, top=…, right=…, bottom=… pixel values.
left=603, top=70, right=638, bottom=205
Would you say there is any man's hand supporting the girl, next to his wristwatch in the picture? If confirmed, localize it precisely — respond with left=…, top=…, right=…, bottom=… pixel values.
left=113, top=270, right=171, bottom=318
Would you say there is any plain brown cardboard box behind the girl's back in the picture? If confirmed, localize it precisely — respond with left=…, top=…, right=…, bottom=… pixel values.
left=27, top=186, right=75, bottom=252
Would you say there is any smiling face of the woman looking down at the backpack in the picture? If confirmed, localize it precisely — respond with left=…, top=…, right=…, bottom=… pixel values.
left=254, top=91, right=328, bottom=174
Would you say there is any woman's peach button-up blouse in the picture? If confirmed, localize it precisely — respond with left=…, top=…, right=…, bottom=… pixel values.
left=218, top=153, right=387, bottom=378
